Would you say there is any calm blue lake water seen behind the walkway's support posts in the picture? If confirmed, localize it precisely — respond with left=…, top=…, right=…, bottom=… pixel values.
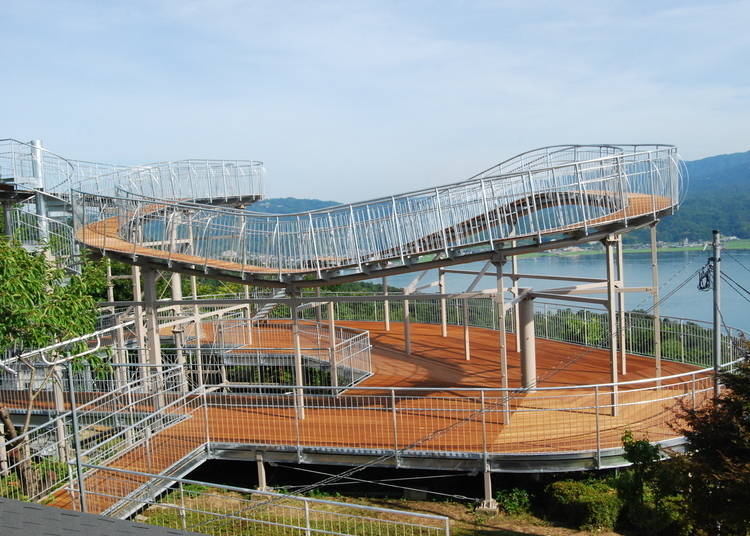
left=382, top=250, right=750, bottom=331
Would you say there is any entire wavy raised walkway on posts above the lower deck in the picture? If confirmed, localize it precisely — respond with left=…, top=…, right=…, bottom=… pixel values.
left=72, top=145, right=681, bottom=287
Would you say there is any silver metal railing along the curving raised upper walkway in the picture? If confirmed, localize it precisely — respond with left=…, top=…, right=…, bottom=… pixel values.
left=70, top=146, right=680, bottom=275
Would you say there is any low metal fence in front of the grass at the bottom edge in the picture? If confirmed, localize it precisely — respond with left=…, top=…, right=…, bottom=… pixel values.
left=77, top=464, right=450, bottom=536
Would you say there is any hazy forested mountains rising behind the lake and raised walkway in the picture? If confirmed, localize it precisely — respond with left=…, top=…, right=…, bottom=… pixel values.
left=248, top=151, right=750, bottom=242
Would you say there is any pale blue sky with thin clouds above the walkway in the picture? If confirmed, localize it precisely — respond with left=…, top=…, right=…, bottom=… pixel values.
left=0, top=0, right=750, bottom=202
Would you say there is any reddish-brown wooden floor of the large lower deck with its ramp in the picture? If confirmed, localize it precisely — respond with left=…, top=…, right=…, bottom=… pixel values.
left=52, top=322, right=711, bottom=512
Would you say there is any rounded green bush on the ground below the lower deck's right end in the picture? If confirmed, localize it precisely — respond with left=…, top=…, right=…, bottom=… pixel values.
left=545, top=480, right=622, bottom=530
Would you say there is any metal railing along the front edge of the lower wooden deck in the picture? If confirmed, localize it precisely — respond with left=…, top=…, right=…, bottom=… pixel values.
left=207, top=370, right=714, bottom=459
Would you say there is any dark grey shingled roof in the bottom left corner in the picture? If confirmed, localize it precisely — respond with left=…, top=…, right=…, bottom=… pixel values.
left=0, top=497, right=206, bottom=536
